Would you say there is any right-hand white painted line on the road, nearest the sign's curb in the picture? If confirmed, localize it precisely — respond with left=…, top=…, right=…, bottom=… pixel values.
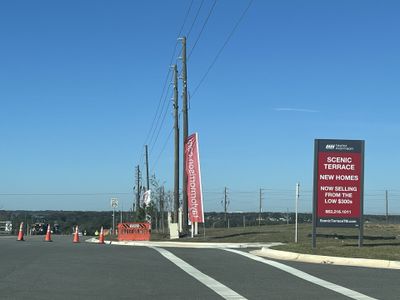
left=223, top=249, right=377, bottom=300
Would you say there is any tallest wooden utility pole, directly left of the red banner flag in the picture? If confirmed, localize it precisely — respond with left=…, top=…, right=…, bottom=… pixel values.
left=180, top=36, right=189, bottom=232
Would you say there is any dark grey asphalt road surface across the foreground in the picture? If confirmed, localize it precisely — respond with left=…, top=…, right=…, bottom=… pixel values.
left=0, top=236, right=400, bottom=299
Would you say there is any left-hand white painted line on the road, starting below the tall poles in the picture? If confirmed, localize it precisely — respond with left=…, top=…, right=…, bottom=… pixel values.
left=150, top=247, right=246, bottom=300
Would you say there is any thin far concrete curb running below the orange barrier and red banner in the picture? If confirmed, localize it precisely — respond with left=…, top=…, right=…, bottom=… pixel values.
left=85, top=238, right=282, bottom=249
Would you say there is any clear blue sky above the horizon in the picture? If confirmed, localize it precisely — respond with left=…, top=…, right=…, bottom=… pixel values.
left=0, top=0, right=400, bottom=213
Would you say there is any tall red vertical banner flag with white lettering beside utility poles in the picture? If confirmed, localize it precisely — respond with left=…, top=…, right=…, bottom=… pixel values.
left=185, top=133, right=204, bottom=223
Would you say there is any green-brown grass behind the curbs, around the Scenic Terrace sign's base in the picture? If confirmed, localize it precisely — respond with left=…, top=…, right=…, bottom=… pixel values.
left=152, top=224, right=400, bottom=261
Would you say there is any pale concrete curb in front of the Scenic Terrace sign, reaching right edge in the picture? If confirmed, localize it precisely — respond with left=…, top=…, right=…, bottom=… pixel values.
left=250, top=247, right=400, bottom=270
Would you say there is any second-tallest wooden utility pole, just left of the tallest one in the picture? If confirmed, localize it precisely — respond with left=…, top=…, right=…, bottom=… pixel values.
left=173, top=65, right=179, bottom=223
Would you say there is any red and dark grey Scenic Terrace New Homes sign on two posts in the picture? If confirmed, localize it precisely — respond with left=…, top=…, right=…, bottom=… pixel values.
left=312, top=139, right=364, bottom=248
